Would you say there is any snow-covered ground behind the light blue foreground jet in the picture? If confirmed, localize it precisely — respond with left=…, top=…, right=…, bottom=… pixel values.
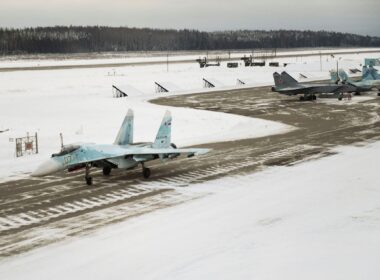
left=0, top=50, right=380, bottom=180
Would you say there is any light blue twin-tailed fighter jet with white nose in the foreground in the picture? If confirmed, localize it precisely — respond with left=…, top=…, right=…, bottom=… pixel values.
left=32, top=110, right=209, bottom=185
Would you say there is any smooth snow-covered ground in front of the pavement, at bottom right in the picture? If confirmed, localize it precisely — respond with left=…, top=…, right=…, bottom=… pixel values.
left=0, top=142, right=380, bottom=280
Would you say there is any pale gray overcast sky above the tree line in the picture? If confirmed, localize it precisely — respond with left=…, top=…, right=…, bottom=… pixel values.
left=0, top=0, right=380, bottom=36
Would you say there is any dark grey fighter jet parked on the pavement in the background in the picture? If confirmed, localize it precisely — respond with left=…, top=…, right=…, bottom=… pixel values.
left=272, top=72, right=355, bottom=101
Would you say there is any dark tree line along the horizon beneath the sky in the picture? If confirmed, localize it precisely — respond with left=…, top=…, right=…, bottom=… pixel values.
left=0, top=26, right=380, bottom=55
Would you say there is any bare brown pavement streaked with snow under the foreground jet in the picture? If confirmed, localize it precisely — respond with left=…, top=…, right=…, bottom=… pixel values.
left=0, top=87, right=380, bottom=258
